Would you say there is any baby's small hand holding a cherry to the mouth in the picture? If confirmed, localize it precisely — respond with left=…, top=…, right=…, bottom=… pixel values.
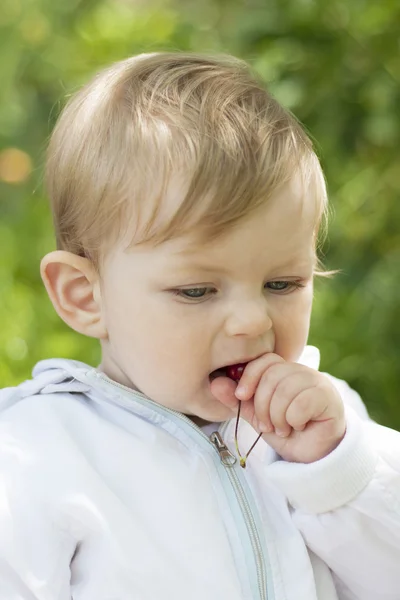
left=211, top=353, right=346, bottom=463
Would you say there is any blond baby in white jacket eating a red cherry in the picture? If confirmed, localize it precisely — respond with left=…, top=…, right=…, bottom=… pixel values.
left=0, top=53, right=400, bottom=600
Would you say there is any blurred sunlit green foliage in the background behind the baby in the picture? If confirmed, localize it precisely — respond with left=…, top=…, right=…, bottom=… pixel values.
left=0, top=0, right=400, bottom=429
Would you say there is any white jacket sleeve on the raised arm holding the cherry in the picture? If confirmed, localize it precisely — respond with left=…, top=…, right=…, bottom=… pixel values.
left=267, top=376, right=400, bottom=600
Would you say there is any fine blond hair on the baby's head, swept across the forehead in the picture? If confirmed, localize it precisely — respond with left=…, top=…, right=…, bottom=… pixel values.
left=46, top=52, right=327, bottom=268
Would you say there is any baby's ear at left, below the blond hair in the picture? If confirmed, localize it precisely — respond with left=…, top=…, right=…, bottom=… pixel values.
left=40, top=250, right=107, bottom=339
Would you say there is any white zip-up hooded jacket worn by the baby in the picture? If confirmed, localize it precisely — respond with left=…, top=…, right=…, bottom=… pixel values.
left=0, top=347, right=400, bottom=600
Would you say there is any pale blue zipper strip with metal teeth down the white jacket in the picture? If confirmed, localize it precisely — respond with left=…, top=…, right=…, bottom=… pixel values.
left=92, top=369, right=267, bottom=600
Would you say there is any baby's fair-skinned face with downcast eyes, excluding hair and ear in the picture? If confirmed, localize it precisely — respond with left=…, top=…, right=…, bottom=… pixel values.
left=100, top=177, right=315, bottom=421
